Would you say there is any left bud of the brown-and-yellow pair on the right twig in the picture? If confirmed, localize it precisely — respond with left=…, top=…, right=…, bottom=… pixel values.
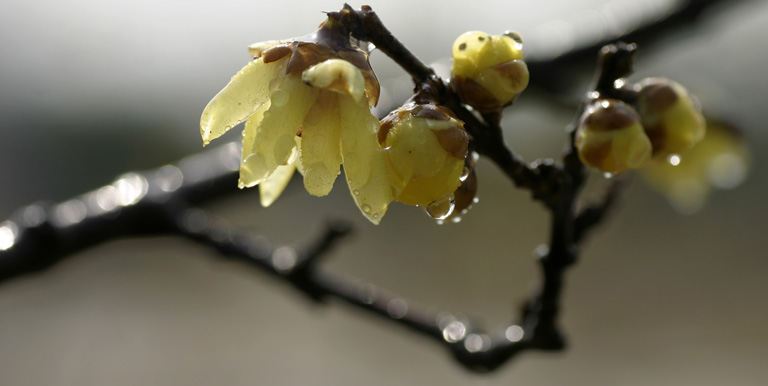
left=576, top=99, right=651, bottom=174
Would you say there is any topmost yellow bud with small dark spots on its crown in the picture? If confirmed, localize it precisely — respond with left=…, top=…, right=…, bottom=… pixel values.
left=451, top=31, right=529, bottom=112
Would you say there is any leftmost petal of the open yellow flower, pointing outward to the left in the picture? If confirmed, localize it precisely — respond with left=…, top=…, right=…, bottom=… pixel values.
left=200, top=59, right=288, bottom=145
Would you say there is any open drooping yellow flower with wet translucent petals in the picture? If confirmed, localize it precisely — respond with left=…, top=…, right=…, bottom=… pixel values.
left=200, top=24, right=394, bottom=223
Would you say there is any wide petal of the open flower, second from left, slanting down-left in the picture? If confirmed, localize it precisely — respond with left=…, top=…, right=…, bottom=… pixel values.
left=240, top=76, right=318, bottom=186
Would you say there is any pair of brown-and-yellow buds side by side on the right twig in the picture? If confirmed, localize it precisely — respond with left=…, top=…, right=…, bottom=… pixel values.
left=576, top=78, right=706, bottom=174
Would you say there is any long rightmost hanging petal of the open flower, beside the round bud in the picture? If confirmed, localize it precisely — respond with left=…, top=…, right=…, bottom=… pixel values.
left=339, top=96, right=394, bottom=224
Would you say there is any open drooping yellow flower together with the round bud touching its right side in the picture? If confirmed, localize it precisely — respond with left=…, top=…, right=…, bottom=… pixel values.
left=200, top=15, right=468, bottom=224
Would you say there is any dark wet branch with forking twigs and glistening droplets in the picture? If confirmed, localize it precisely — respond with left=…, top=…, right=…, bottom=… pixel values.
left=0, top=0, right=732, bottom=371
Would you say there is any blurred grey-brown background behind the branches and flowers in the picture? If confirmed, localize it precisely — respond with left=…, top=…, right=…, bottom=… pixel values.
left=0, top=0, right=768, bottom=386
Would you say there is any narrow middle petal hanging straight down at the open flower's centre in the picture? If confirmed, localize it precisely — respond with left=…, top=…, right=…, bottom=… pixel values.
left=301, top=91, right=342, bottom=196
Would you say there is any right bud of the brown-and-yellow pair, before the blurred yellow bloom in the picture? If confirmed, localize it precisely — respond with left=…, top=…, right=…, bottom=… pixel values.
left=637, top=78, right=706, bottom=159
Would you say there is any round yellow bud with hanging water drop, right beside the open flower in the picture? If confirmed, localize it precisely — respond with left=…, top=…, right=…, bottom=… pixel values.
left=378, top=103, right=468, bottom=211
